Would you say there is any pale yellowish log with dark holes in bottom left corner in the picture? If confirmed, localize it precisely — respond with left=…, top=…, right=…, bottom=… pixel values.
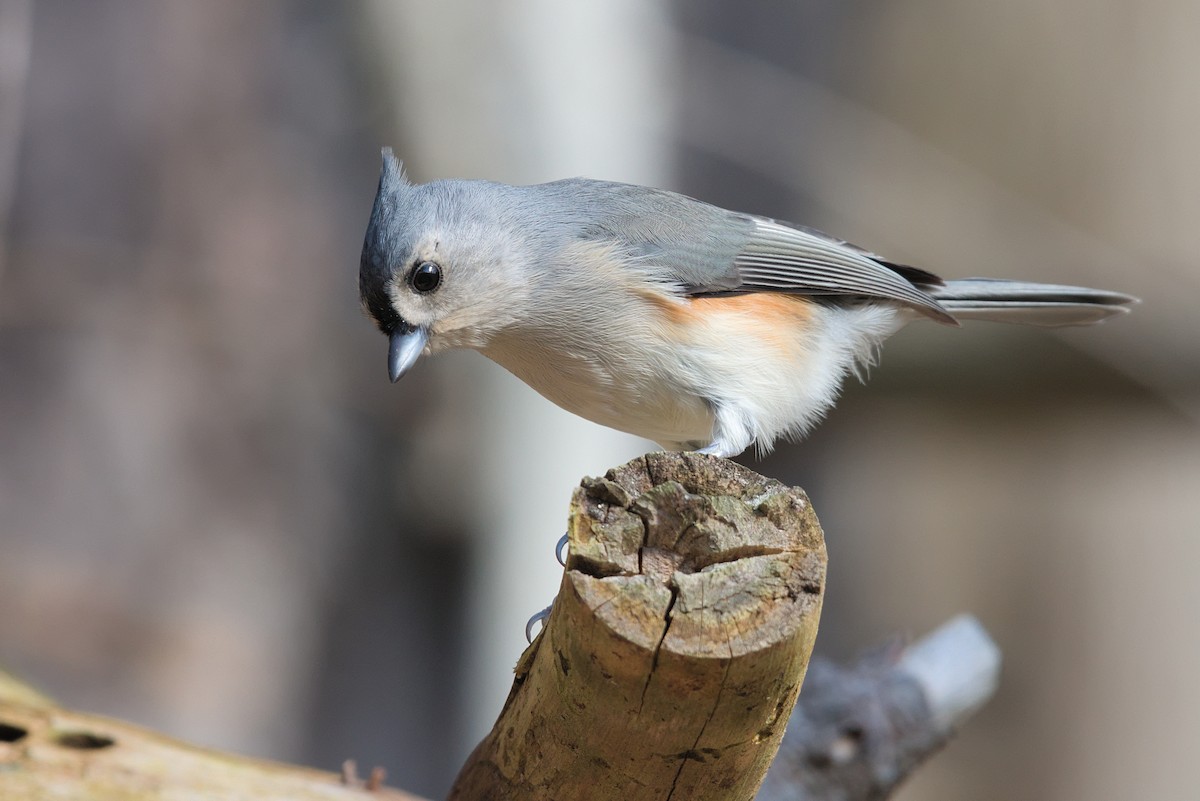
left=0, top=674, right=421, bottom=801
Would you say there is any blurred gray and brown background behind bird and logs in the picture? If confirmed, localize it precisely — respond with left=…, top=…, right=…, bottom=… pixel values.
left=0, top=0, right=1200, bottom=800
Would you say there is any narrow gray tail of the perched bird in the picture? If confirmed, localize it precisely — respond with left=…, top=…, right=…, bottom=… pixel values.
left=926, top=278, right=1138, bottom=327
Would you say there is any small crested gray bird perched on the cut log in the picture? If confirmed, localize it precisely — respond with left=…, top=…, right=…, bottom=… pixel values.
left=359, top=149, right=1134, bottom=457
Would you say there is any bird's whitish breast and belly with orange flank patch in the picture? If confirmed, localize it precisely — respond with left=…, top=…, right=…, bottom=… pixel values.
left=484, top=288, right=904, bottom=451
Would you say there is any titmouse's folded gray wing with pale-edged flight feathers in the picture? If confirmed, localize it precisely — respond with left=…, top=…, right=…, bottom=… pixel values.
left=538, top=179, right=958, bottom=325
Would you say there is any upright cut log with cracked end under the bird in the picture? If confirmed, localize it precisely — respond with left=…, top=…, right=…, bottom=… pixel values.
left=450, top=453, right=826, bottom=801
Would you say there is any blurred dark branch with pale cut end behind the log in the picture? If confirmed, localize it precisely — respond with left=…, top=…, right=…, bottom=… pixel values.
left=758, top=615, right=1000, bottom=801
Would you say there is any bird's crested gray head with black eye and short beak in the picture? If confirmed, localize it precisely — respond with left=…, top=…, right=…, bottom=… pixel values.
left=359, top=147, right=537, bottom=381
